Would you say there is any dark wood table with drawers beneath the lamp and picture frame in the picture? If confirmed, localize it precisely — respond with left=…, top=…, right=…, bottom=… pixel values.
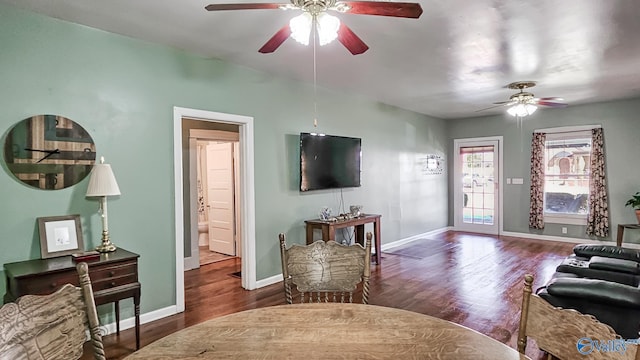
left=4, top=249, right=140, bottom=349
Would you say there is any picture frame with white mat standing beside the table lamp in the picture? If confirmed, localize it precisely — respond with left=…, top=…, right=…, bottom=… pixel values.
left=38, top=215, right=84, bottom=259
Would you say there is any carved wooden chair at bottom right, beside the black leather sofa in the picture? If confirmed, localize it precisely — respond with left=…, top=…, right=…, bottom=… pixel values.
left=518, top=275, right=640, bottom=360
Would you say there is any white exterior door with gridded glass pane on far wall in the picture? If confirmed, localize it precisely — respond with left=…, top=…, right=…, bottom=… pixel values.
left=460, top=146, right=495, bottom=225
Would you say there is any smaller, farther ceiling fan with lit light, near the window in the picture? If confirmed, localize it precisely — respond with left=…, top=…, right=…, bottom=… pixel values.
left=476, top=81, right=568, bottom=117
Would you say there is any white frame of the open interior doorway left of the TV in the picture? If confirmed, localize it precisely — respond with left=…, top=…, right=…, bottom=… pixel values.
left=173, top=106, right=256, bottom=312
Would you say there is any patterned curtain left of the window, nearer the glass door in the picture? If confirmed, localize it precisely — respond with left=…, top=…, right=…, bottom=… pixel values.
left=529, top=133, right=547, bottom=229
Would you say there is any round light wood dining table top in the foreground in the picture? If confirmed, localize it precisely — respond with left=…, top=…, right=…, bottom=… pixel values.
left=125, top=303, right=529, bottom=360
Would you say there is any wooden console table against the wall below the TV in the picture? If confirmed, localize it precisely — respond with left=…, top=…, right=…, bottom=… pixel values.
left=304, top=214, right=381, bottom=264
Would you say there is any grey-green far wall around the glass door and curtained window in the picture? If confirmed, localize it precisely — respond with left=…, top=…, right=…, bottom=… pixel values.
left=448, top=99, right=640, bottom=243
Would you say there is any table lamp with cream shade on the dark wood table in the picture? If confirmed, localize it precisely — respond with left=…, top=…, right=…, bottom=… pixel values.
left=87, top=157, right=120, bottom=253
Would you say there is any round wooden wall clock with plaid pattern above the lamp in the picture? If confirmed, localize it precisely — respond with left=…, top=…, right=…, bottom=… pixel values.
left=4, top=115, right=96, bottom=190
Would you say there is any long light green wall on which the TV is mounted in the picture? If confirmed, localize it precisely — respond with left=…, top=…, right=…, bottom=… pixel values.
left=0, top=5, right=448, bottom=317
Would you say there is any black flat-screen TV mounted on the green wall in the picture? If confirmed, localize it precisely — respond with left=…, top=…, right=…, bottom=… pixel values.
left=300, top=133, right=361, bottom=191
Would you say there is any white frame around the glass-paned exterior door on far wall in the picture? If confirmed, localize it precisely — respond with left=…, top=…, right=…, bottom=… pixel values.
left=453, top=136, right=504, bottom=235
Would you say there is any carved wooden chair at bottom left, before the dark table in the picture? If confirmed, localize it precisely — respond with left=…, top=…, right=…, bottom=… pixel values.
left=0, top=262, right=106, bottom=360
